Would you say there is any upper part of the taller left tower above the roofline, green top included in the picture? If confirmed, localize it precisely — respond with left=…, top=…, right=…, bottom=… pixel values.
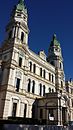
left=6, top=0, right=28, bottom=44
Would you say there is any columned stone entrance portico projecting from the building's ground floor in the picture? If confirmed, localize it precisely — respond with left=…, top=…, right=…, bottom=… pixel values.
left=35, top=93, right=68, bottom=125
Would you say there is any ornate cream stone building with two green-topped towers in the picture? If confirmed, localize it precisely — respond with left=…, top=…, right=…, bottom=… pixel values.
left=0, top=0, right=73, bottom=125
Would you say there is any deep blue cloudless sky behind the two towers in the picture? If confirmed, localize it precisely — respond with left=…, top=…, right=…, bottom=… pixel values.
left=0, top=0, right=73, bottom=79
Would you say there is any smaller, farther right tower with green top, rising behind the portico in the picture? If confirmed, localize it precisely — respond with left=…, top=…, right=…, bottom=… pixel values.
left=48, top=34, right=65, bottom=93
